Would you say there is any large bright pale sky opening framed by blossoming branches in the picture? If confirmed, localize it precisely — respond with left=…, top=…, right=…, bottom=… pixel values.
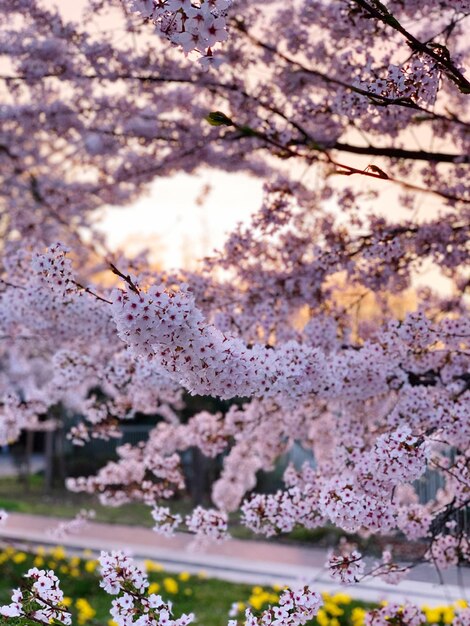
left=95, top=171, right=262, bottom=268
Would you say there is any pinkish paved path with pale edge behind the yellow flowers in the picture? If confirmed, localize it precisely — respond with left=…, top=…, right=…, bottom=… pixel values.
left=0, top=513, right=470, bottom=606
